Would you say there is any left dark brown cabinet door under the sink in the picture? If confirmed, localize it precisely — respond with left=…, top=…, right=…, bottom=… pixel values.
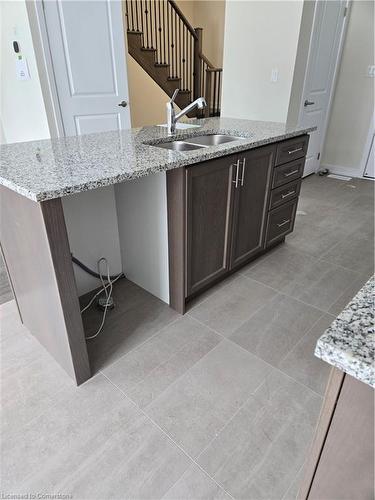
left=186, top=155, right=237, bottom=296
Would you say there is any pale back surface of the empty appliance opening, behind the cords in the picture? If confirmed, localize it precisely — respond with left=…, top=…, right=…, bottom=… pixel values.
left=62, top=186, right=122, bottom=295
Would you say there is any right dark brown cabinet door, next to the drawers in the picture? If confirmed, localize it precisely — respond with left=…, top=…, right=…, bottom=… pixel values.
left=231, top=146, right=275, bottom=268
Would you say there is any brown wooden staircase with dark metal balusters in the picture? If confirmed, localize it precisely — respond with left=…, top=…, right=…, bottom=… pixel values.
left=124, top=0, right=222, bottom=117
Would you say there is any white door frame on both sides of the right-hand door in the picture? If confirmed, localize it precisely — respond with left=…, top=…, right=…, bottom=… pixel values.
left=297, top=0, right=352, bottom=176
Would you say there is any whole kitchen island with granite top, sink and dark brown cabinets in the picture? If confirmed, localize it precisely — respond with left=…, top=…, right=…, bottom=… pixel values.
left=0, top=118, right=313, bottom=384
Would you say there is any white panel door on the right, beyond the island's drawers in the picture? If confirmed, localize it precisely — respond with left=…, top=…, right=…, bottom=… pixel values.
left=299, top=0, right=347, bottom=176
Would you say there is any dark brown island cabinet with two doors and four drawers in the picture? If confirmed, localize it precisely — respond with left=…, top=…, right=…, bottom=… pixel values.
left=167, top=135, right=308, bottom=313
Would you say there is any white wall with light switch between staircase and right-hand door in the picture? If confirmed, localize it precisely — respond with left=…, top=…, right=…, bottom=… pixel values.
left=222, top=0, right=303, bottom=122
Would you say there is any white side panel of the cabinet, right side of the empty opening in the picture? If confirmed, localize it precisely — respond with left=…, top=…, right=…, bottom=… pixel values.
left=115, top=172, right=169, bottom=304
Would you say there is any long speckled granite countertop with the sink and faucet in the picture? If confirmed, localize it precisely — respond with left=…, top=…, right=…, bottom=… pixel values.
left=0, top=118, right=315, bottom=202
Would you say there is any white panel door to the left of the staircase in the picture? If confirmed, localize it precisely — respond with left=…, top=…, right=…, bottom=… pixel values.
left=43, top=0, right=130, bottom=135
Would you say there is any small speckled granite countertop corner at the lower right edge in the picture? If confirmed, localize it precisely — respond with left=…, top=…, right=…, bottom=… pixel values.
left=315, top=276, right=375, bottom=388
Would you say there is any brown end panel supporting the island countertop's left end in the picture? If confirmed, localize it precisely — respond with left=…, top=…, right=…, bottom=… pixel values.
left=0, top=187, right=91, bottom=385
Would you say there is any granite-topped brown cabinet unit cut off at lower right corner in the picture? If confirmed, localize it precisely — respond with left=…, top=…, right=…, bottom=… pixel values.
left=299, top=277, right=375, bottom=500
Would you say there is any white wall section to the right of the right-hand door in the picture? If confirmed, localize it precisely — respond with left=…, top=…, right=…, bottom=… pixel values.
left=322, top=0, right=375, bottom=175
